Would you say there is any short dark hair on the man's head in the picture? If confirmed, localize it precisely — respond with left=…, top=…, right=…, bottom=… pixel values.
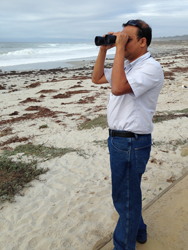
left=136, top=19, right=152, bottom=46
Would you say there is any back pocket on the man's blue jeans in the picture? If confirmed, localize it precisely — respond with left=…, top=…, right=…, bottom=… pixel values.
left=135, top=144, right=151, bottom=174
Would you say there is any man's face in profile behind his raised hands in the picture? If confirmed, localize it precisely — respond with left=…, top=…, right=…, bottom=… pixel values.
left=123, top=26, right=142, bottom=62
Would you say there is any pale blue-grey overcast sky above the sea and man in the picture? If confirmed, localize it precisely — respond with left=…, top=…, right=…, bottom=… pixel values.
left=0, top=0, right=188, bottom=42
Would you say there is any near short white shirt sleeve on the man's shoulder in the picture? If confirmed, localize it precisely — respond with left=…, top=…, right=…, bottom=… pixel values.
left=126, top=63, right=163, bottom=98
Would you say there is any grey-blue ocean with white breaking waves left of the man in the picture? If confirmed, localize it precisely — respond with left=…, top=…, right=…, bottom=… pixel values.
left=0, top=42, right=115, bottom=71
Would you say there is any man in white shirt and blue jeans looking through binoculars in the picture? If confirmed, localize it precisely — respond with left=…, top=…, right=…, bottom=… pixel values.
left=92, top=20, right=164, bottom=250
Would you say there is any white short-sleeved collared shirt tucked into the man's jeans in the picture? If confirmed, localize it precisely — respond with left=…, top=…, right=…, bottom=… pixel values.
left=104, top=52, right=164, bottom=134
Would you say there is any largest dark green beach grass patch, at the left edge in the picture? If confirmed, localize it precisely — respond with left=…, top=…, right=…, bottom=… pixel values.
left=0, top=144, right=80, bottom=203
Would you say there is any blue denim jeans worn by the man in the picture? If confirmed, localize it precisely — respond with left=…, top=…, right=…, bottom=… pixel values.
left=108, top=134, right=151, bottom=250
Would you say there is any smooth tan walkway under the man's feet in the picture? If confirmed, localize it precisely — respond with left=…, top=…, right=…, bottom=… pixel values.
left=93, top=172, right=188, bottom=250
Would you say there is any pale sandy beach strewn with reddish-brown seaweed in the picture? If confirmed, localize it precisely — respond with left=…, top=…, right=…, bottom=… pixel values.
left=0, top=41, right=188, bottom=250
